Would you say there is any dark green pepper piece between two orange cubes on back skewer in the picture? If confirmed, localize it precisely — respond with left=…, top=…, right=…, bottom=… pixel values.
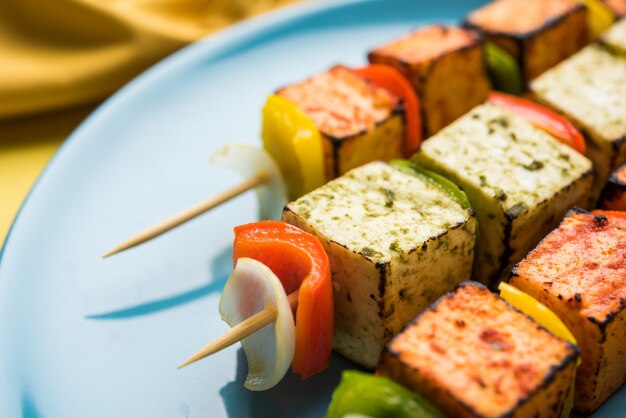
left=484, top=42, right=524, bottom=96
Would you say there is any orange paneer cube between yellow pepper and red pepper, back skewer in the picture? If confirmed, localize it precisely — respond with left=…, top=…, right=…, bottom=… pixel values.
left=277, top=66, right=406, bottom=180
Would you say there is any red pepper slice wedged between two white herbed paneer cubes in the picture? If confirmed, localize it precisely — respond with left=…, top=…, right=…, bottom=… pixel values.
left=488, top=92, right=586, bottom=154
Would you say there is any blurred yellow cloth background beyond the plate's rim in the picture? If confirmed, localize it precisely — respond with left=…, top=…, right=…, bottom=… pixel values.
left=0, top=0, right=295, bottom=244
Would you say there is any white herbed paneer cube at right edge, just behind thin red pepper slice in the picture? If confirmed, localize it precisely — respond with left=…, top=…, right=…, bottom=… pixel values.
left=531, top=45, right=626, bottom=206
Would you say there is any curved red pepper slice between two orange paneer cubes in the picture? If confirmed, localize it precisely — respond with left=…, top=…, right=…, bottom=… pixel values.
left=353, top=64, right=422, bottom=157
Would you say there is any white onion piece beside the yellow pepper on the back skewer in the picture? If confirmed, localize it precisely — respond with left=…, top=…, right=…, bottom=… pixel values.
left=210, top=144, right=287, bottom=220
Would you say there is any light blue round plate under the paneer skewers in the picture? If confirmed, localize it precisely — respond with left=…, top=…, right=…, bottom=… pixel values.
left=0, top=0, right=626, bottom=418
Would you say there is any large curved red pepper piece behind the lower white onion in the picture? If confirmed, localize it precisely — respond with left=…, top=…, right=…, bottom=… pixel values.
left=233, top=221, right=334, bottom=378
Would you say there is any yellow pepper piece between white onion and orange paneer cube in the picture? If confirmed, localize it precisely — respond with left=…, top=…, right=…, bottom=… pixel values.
left=261, top=95, right=326, bottom=200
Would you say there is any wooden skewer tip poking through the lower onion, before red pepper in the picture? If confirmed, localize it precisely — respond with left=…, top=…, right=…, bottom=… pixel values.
left=178, top=290, right=299, bottom=369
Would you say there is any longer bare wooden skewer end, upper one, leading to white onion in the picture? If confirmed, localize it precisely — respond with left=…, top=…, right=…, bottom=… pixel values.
left=102, top=171, right=269, bottom=258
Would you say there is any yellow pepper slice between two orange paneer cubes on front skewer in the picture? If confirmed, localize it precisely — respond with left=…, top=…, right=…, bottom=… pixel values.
left=498, top=282, right=580, bottom=418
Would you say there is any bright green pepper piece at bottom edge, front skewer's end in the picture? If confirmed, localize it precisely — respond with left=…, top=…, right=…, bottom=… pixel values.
left=326, top=370, right=445, bottom=418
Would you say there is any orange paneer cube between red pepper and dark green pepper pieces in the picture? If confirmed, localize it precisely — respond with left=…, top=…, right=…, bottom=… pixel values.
left=368, top=25, right=490, bottom=137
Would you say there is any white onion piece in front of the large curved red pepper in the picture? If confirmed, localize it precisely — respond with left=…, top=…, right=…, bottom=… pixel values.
left=219, top=257, right=296, bottom=391
